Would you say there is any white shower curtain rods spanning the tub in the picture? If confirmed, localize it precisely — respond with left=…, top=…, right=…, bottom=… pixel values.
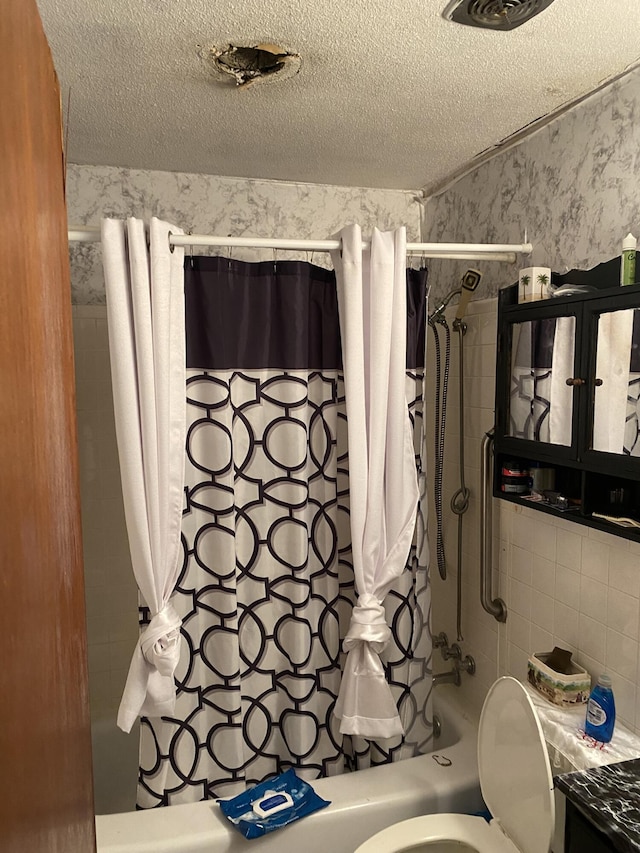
left=69, top=225, right=533, bottom=263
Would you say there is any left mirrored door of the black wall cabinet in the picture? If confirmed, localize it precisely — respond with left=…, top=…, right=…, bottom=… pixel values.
left=508, top=316, right=576, bottom=446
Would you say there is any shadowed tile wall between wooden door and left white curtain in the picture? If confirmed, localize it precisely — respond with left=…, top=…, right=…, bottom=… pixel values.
left=72, top=305, right=138, bottom=814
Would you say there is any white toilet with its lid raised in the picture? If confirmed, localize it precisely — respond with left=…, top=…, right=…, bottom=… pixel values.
left=356, top=677, right=555, bottom=853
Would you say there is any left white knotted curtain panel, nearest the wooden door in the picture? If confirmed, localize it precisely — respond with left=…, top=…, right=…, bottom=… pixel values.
left=102, top=218, right=186, bottom=732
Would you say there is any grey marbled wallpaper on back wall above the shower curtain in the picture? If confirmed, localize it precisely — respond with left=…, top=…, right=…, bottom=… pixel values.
left=67, top=165, right=422, bottom=305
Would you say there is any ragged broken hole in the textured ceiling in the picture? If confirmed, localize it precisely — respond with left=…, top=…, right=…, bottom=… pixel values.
left=206, top=44, right=302, bottom=87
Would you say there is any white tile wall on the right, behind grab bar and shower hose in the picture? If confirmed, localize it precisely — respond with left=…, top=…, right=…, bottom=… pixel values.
left=426, top=300, right=640, bottom=733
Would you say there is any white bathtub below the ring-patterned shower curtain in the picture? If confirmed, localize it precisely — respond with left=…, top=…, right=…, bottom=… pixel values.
left=96, top=685, right=483, bottom=853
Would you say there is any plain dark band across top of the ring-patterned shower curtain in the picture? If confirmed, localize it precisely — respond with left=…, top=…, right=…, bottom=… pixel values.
left=185, top=257, right=427, bottom=370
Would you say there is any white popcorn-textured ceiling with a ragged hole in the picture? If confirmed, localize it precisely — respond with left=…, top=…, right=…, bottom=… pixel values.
left=39, top=0, right=640, bottom=189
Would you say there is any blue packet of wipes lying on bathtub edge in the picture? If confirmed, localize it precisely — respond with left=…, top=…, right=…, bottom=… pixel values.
left=218, top=768, right=331, bottom=838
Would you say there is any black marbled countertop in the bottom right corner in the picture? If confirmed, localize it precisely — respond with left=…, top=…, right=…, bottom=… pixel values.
left=555, top=758, right=640, bottom=853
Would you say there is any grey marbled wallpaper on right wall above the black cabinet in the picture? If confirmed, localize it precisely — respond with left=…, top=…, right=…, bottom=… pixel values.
left=423, top=72, right=640, bottom=299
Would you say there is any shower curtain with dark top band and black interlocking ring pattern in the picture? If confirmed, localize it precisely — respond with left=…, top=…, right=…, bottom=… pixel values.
left=138, top=257, right=432, bottom=808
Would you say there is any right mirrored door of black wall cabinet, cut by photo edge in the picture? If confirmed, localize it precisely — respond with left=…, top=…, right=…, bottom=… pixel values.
left=592, top=308, right=640, bottom=456
